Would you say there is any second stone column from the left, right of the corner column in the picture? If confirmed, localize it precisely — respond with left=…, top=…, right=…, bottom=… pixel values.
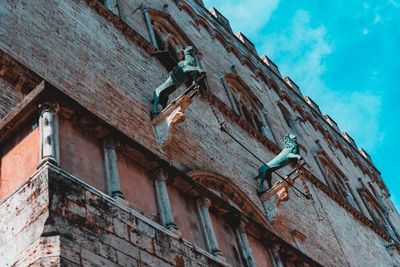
left=103, top=138, right=124, bottom=198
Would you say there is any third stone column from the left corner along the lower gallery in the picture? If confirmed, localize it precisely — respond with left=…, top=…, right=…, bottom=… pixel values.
left=154, top=169, right=177, bottom=231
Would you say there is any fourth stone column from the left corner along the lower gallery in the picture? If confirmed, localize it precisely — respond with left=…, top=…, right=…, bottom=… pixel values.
left=197, top=197, right=222, bottom=256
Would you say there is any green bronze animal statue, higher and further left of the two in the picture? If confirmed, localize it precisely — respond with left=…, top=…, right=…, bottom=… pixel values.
left=151, top=46, right=205, bottom=117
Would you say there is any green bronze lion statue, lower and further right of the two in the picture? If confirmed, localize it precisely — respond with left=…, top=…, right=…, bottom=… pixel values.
left=256, top=133, right=301, bottom=195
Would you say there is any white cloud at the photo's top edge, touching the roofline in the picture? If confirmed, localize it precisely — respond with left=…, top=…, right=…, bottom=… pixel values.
left=204, top=0, right=280, bottom=36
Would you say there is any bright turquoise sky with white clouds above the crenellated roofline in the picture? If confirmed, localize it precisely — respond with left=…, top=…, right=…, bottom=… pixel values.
left=204, top=0, right=400, bottom=211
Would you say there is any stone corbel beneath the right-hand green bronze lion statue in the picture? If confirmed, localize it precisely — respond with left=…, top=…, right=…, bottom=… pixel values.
left=260, top=178, right=294, bottom=222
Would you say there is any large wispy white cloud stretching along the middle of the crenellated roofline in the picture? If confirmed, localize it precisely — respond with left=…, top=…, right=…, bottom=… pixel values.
left=264, top=10, right=383, bottom=151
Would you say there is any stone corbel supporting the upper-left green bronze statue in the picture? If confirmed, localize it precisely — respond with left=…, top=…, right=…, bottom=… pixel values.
left=153, top=95, right=192, bottom=148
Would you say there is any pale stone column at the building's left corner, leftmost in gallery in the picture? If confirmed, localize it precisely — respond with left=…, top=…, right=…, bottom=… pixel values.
left=39, top=102, right=60, bottom=166
